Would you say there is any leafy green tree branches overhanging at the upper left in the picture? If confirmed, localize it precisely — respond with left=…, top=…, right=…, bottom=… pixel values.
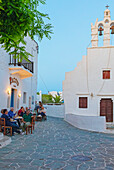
left=0, top=0, right=52, bottom=59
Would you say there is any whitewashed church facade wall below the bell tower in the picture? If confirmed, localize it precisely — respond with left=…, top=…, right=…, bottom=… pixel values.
left=63, top=46, right=114, bottom=121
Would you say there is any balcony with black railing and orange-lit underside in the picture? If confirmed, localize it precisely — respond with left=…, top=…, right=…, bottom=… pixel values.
left=9, top=55, right=34, bottom=79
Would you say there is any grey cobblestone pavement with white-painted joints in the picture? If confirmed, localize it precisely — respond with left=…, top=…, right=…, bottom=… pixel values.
left=0, top=118, right=114, bottom=170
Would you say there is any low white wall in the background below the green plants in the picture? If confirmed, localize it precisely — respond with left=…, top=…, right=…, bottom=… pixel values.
left=44, top=105, right=65, bottom=118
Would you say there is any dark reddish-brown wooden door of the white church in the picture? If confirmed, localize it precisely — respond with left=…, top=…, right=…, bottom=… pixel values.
left=100, top=99, right=113, bottom=122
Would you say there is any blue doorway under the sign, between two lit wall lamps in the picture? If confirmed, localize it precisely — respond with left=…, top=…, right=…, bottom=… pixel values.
left=10, top=88, right=17, bottom=111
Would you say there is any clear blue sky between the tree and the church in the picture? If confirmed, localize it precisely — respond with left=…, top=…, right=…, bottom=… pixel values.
left=38, top=0, right=114, bottom=93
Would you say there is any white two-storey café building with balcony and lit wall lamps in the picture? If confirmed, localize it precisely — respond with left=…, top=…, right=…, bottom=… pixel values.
left=0, top=36, right=38, bottom=111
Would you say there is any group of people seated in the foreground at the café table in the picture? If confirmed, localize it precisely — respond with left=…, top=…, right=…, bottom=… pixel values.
left=0, top=107, right=32, bottom=135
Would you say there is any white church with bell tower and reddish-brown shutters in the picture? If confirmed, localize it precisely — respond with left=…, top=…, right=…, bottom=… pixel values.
left=63, top=6, right=114, bottom=132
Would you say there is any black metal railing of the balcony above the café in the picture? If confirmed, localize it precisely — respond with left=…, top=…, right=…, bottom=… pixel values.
left=9, top=55, right=34, bottom=73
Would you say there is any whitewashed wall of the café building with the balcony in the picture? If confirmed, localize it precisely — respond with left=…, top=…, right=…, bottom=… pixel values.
left=0, top=37, right=38, bottom=109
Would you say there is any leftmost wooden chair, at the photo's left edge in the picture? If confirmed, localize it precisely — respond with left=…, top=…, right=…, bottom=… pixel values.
left=0, top=118, right=12, bottom=136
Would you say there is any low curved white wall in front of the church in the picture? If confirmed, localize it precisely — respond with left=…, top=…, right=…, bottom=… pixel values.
left=65, top=114, right=106, bottom=132
